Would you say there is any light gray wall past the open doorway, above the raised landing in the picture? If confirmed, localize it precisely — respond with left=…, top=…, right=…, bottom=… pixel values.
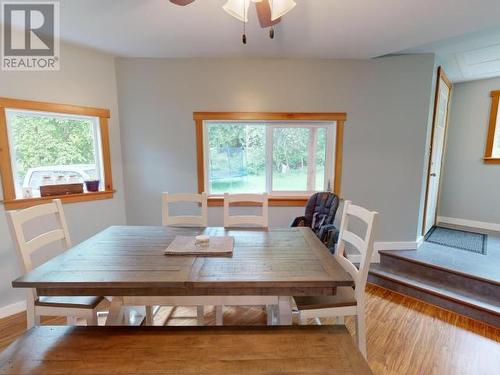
left=439, top=78, right=500, bottom=224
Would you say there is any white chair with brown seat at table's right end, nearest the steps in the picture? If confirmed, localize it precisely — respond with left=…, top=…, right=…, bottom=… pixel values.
left=294, top=201, right=377, bottom=358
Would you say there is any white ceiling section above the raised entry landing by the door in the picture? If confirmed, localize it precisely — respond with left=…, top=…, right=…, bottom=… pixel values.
left=404, top=26, right=500, bottom=82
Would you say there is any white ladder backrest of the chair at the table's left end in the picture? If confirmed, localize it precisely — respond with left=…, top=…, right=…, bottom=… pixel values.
left=8, top=199, right=71, bottom=272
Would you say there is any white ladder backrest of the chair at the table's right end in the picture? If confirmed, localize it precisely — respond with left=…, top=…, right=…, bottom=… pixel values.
left=334, top=201, right=378, bottom=301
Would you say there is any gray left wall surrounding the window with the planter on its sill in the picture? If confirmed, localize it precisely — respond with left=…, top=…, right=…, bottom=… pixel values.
left=0, top=45, right=125, bottom=308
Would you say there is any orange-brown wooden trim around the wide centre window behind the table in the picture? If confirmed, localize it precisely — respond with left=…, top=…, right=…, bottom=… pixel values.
left=193, top=112, right=347, bottom=207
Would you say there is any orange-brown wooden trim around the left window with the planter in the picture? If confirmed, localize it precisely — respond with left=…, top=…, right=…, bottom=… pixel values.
left=0, top=98, right=115, bottom=210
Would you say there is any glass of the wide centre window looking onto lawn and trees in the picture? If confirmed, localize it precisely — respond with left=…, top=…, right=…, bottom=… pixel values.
left=205, top=121, right=335, bottom=195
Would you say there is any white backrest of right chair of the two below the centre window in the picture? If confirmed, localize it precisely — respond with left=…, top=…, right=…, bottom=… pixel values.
left=224, top=193, right=269, bottom=228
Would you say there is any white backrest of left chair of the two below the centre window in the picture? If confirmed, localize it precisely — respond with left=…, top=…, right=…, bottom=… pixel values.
left=162, top=193, right=208, bottom=227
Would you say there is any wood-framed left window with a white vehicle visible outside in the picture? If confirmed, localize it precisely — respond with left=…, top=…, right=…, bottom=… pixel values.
left=0, top=99, right=112, bottom=208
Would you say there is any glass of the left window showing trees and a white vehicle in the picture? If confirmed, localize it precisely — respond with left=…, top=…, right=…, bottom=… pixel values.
left=8, top=111, right=99, bottom=198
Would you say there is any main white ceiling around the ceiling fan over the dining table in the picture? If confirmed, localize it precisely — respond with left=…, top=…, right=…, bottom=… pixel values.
left=48, top=0, right=500, bottom=59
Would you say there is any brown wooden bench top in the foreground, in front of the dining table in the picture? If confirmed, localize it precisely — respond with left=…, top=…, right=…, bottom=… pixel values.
left=0, top=326, right=372, bottom=375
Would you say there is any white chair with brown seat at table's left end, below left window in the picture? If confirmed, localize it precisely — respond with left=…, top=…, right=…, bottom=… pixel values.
left=8, top=199, right=104, bottom=329
